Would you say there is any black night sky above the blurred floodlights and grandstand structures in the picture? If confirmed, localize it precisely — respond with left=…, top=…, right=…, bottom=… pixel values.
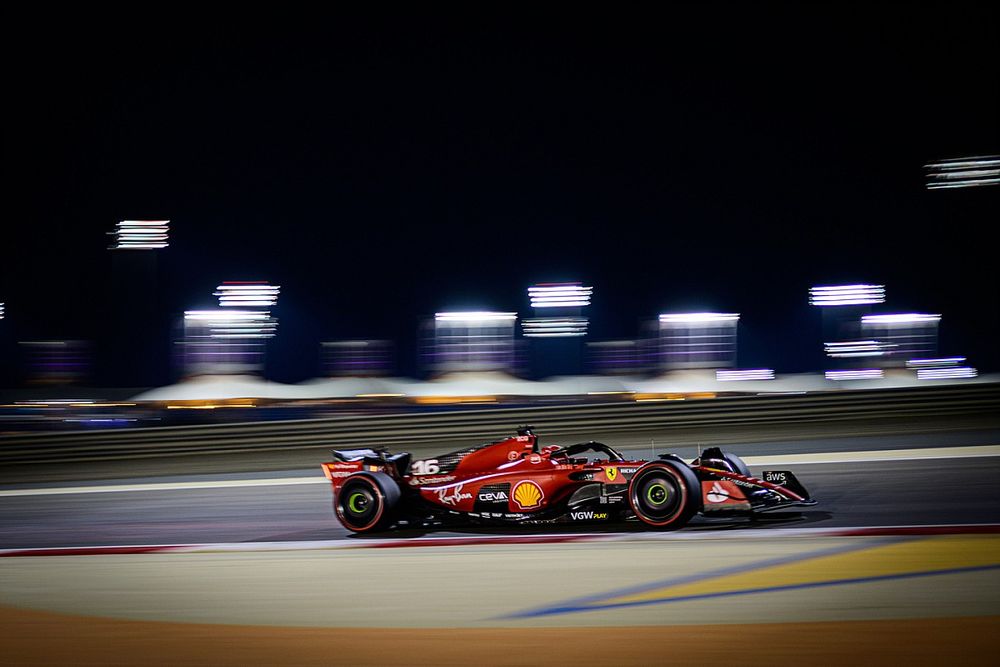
left=0, top=3, right=1000, bottom=385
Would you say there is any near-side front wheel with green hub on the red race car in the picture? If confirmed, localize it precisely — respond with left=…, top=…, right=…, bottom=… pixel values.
left=628, top=461, right=700, bottom=529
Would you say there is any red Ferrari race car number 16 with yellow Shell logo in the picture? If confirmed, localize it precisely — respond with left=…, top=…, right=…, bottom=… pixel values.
left=322, top=427, right=816, bottom=533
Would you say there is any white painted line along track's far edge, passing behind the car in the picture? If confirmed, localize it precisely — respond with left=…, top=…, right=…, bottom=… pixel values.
left=0, top=445, right=1000, bottom=498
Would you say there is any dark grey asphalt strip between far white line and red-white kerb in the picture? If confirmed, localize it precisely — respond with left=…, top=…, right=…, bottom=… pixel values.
left=0, top=432, right=1000, bottom=549
